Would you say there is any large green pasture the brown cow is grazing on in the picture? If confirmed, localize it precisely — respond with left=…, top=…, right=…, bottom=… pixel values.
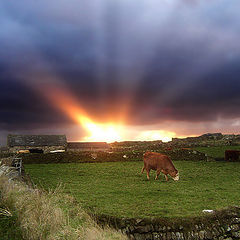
left=25, top=161, right=240, bottom=218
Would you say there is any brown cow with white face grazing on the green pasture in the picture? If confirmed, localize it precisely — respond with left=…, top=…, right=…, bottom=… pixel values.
left=141, top=152, right=179, bottom=181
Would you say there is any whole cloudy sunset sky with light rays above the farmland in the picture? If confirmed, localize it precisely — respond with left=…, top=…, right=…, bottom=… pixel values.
left=0, top=0, right=240, bottom=145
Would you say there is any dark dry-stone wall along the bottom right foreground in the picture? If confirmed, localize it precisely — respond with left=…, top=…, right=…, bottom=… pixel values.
left=95, top=207, right=240, bottom=240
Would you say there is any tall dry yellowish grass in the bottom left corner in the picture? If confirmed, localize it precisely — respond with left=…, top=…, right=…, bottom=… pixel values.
left=0, top=170, right=126, bottom=240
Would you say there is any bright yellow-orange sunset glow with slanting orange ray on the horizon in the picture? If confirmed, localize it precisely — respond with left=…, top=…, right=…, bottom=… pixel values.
left=38, top=80, right=176, bottom=142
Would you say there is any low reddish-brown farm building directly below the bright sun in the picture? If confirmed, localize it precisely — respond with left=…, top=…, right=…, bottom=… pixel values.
left=67, top=142, right=110, bottom=152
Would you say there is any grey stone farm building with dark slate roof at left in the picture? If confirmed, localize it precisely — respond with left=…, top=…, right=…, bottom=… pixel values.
left=7, top=134, right=67, bottom=152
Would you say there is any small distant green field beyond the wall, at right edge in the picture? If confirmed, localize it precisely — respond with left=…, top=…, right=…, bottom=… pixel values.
left=194, top=146, right=240, bottom=158
